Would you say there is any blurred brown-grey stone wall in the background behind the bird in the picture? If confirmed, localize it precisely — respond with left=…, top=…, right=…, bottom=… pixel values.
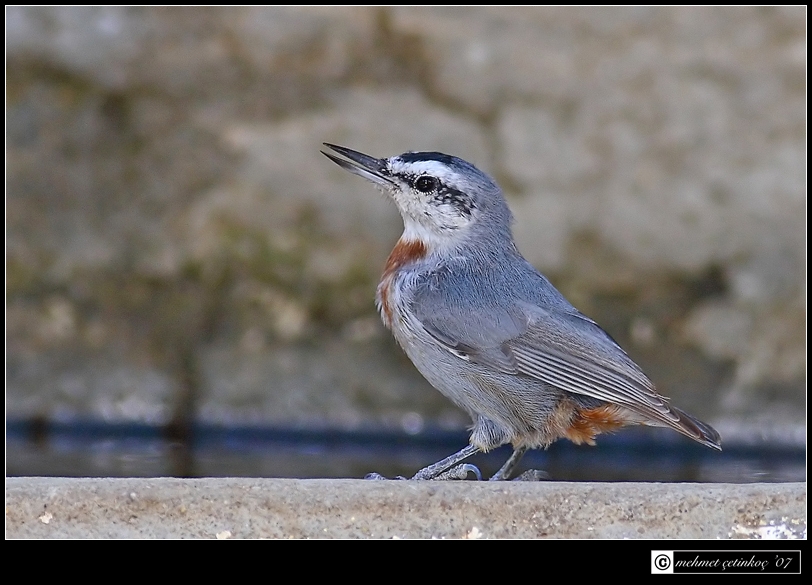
left=6, top=7, right=806, bottom=438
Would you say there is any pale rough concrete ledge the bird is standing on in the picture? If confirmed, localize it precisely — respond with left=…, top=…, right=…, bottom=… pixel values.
left=6, top=477, right=806, bottom=538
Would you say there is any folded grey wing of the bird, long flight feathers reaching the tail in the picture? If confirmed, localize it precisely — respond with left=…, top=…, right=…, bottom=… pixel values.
left=412, top=294, right=718, bottom=448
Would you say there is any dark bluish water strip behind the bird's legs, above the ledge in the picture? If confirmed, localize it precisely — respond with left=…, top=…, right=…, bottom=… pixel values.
left=6, top=421, right=806, bottom=483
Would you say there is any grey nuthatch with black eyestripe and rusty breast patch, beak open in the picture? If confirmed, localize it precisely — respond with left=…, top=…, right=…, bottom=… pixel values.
left=321, top=142, right=721, bottom=480
